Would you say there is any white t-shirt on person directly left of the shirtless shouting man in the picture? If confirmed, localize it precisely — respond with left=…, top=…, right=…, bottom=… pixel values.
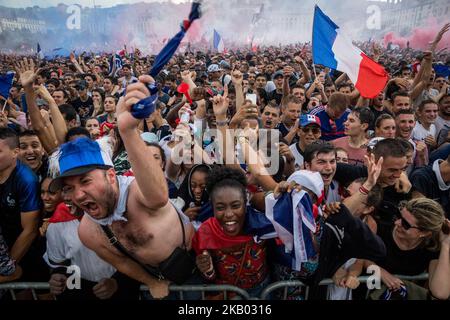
left=44, top=220, right=116, bottom=282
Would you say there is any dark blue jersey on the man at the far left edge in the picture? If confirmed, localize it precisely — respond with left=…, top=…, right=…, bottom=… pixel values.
left=0, top=160, right=41, bottom=248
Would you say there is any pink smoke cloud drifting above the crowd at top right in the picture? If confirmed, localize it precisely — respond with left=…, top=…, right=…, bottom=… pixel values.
left=383, top=18, right=450, bottom=50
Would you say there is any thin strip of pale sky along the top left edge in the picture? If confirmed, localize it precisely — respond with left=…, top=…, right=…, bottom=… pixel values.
left=0, top=0, right=187, bottom=8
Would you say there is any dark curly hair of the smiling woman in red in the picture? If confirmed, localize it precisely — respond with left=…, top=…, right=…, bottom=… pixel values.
left=206, top=166, right=247, bottom=202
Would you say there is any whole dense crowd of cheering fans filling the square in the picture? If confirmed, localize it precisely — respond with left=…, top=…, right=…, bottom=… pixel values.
left=0, top=24, right=450, bottom=300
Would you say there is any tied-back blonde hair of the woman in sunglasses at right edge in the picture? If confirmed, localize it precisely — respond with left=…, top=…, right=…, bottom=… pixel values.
left=405, top=198, right=445, bottom=251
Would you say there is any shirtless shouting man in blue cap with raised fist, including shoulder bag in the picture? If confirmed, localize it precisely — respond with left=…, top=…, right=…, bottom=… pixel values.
left=53, top=76, right=195, bottom=298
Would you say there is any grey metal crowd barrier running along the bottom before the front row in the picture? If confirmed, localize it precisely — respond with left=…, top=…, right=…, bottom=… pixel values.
left=0, top=273, right=428, bottom=300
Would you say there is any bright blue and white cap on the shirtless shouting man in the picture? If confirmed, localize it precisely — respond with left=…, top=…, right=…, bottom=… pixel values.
left=49, top=137, right=113, bottom=192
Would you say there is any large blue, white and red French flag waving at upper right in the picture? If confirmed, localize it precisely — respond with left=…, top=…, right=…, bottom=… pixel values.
left=312, top=6, right=388, bottom=98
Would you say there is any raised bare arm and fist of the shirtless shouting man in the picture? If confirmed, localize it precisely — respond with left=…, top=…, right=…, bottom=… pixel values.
left=117, top=76, right=169, bottom=210
